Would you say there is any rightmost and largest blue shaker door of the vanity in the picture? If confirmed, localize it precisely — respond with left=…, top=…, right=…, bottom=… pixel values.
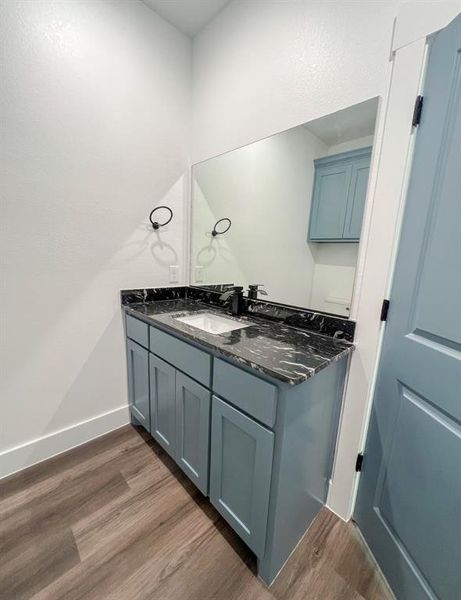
left=210, top=396, right=274, bottom=557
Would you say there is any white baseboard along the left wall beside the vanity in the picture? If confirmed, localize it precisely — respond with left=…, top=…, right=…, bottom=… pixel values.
left=0, top=405, right=130, bottom=479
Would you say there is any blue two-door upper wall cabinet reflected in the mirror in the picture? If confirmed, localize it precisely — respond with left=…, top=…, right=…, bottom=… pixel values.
left=309, top=146, right=371, bottom=242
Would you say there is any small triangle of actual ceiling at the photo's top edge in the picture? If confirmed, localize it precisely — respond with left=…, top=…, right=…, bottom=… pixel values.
left=142, top=0, right=231, bottom=37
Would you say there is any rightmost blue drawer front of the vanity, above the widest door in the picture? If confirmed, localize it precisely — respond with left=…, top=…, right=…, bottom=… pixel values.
left=213, top=358, right=277, bottom=427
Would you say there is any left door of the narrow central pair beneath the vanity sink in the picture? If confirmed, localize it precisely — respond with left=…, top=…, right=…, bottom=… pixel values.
left=149, top=354, right=176, bottom=457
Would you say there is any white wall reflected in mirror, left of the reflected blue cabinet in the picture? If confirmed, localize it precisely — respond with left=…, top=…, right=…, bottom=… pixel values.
left=192, top=127, right=328, bottom=306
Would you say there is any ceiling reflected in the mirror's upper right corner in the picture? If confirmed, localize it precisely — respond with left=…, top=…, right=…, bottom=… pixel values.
left=304, top=98, right=378, bottom=146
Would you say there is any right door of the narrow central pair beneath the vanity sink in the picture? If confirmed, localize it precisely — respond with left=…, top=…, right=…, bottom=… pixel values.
left=176, top=371, right=211, bottom=496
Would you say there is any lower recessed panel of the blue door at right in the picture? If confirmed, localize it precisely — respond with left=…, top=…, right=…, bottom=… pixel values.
left=375, top=386, right=461, bottom=591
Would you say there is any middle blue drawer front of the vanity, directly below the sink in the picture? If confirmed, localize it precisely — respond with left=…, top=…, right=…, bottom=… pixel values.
left=150, top=327, right=211, bottom=387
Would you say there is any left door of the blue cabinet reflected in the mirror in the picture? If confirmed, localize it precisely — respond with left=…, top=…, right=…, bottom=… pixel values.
left=309, top=163, right=352, bottom=240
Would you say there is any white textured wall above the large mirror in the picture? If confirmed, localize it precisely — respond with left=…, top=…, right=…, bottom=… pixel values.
left=193, top=0, right=398, bottom=162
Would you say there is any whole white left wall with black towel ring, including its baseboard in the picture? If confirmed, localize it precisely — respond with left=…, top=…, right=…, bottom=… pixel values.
left=0, top=0, right=190, bottom=475
